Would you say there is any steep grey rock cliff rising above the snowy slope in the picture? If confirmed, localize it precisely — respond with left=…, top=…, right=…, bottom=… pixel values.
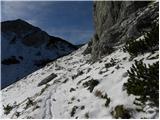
left=85, top=1, right=159, bottom=60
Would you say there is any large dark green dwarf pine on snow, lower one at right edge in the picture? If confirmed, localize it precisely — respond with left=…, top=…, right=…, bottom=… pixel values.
left=123, top=61, right=159, bottom=106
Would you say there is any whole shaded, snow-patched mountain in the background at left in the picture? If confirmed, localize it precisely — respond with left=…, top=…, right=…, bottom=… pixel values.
left=1, top=19, right=76, bottom=88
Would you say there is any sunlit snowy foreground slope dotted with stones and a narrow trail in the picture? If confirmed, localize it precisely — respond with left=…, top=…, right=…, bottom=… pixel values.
left=1, top=45, right=158, bottom=118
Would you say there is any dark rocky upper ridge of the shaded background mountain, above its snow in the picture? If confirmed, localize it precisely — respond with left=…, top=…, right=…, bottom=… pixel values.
left=1, top=19, right=78, bottom=50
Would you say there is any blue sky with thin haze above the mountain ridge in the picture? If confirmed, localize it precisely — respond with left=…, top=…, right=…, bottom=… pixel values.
left=1, top=1, right=94, bottom=44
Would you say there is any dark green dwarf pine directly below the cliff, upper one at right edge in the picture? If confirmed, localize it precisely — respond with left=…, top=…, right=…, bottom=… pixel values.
left=123, top=24, right=159, bottom=57
